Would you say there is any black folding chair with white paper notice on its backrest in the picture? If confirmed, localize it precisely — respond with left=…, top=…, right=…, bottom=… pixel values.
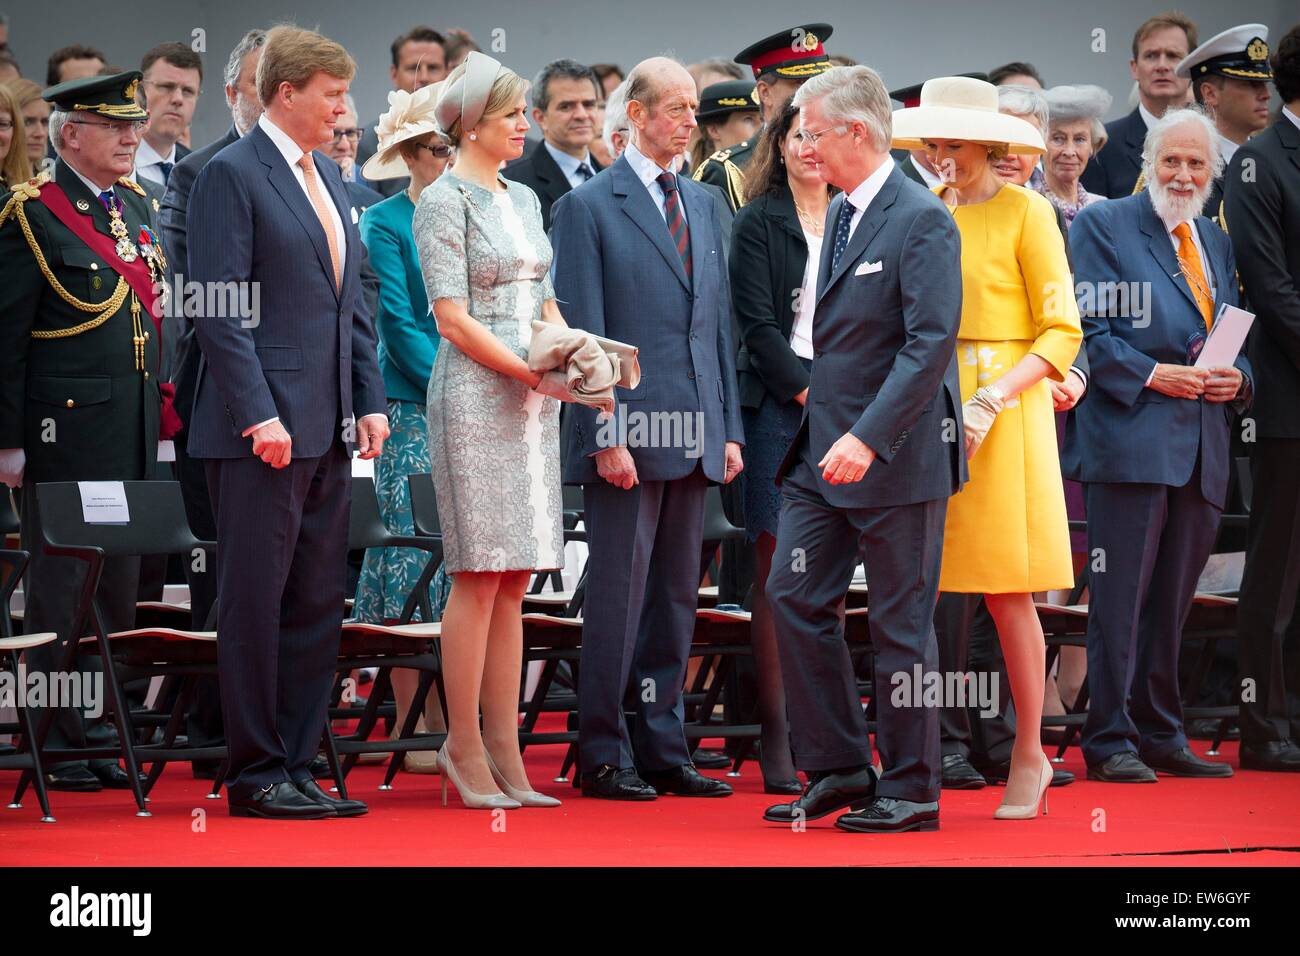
left=14, top=481, right=226, bottom=817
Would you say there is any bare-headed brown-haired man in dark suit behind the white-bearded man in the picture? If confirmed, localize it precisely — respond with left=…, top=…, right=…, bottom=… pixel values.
left=1082, top=10, right=1196, bottom=199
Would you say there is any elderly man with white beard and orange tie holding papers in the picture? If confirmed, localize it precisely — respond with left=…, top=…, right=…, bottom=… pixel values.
left=1062, top=109, right=1251, bottom=783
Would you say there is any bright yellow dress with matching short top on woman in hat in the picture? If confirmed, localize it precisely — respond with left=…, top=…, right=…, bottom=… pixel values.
left=935, top=185, right=1083, bottom=594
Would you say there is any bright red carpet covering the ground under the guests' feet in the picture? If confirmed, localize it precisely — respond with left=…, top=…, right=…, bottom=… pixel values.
left=0, top=741, right=1300, bottom=866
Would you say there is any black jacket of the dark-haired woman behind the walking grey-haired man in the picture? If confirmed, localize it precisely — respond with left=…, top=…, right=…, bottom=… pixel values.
left=729, top=186, right=809, bottom=408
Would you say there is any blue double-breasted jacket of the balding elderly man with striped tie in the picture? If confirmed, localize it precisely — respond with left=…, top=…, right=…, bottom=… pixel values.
left=551, top=156, right=745, bottom=484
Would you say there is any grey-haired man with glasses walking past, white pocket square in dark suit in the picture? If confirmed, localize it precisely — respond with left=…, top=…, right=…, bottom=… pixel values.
left=763, top=66, right=966, bottom=832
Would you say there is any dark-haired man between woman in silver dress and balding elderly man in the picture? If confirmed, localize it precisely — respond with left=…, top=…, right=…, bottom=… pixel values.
left=504, top=60, right=605, bottom=230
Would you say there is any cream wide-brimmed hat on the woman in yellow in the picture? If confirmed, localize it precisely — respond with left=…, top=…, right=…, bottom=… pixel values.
left=893, top=77, right=1047, bottom=153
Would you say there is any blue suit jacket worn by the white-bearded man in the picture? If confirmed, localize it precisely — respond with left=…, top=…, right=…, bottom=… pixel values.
left=1061, top=190, right=1251, bottom=507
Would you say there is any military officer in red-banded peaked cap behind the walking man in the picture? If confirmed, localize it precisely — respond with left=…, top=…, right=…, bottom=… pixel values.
left=693, top=23, right=835, bottom=212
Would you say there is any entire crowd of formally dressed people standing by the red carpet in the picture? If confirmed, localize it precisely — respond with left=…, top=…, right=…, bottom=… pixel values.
left=0, top=12, right=1300, bottom=832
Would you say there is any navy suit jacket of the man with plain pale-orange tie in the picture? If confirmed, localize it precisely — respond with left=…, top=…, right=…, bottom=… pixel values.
left=187, top=126, right=387, bottom=458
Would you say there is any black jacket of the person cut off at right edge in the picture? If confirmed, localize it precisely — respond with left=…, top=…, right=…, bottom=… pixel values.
left=1222, top=116, right=1300, bottom=438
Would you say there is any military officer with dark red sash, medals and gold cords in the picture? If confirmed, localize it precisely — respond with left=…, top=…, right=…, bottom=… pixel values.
left=0, top=70, right=179, bottom=790
